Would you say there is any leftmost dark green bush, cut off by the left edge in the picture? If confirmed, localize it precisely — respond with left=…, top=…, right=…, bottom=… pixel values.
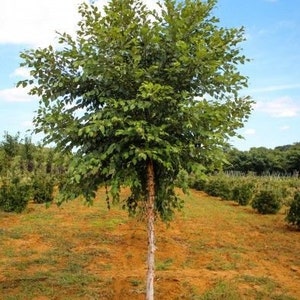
left=0, top=178, right=30, bottom=213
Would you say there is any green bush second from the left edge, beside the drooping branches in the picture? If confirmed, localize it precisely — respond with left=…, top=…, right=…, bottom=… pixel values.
left=32, top=175, right=54, bottom=203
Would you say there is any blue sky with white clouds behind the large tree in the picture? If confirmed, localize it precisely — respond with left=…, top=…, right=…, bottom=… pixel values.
left=0, top=0, right=300, bottom=151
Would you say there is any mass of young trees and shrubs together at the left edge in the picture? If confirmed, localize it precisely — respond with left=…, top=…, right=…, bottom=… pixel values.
left=0, top=132, right=68, bottom=212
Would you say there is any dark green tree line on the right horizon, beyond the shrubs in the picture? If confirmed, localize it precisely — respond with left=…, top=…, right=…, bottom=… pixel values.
left=224, top=142, right=300, bottom=176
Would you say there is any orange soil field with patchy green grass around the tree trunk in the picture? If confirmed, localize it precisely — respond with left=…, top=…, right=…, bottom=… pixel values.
left=0, top=190, right=300, bottom=300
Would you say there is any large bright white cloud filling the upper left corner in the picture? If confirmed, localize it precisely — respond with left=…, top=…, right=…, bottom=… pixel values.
left=0, top=0, right=164, bottom=47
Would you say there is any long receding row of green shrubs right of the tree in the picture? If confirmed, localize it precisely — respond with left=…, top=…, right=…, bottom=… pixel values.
left=190, top=174, right=300, bottom=228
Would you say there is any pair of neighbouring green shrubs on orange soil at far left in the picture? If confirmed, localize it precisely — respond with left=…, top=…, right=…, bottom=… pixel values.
left=0, top=174, right=54, bottom=213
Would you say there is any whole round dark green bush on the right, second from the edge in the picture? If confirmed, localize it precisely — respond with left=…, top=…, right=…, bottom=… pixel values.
left=252, top=190, right=282, bottom=215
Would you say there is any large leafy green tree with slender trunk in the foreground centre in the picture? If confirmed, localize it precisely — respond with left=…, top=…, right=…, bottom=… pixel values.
left=18, top=0, right=252, bottom=299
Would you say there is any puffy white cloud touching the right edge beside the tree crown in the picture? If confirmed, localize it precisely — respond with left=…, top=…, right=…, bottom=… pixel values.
left=254, top=97, right=300, bottom=118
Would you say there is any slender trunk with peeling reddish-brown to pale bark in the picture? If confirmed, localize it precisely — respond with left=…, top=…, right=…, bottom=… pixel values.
left=146, top=160, right=155, bottom=300
